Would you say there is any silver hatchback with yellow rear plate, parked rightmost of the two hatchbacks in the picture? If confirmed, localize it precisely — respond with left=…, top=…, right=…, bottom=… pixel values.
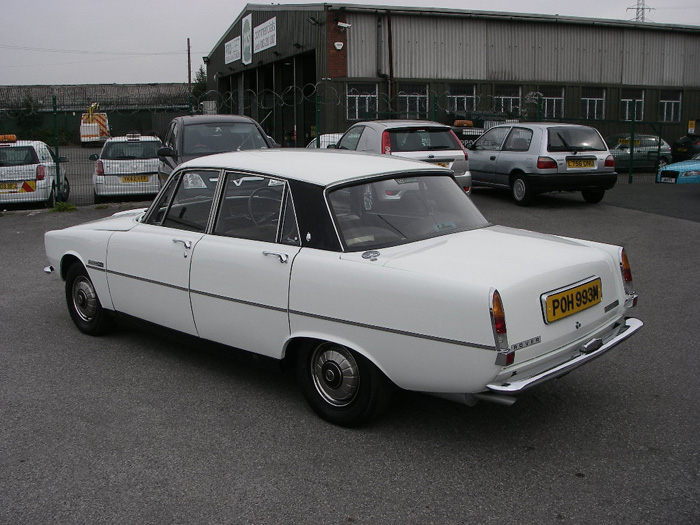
left=469, top=123, right=617, bottom=206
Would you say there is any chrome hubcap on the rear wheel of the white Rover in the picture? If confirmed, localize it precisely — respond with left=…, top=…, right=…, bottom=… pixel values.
left=311, top=343, right=360, bottom=407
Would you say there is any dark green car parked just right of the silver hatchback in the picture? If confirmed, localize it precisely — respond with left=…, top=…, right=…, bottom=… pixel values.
left=605, top=133, right=671, bottom=172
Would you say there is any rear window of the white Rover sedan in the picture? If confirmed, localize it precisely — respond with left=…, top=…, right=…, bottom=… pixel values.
left=329, top=175, right=488, bottom=251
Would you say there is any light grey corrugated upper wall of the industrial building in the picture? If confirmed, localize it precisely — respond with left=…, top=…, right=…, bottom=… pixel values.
left=348, top=12, right=700, bottom=87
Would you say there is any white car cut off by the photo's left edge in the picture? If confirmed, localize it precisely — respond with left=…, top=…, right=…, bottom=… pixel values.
left=0, top=135, right=70, bottom=208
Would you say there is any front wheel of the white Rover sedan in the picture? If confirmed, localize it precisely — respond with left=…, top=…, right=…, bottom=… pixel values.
left=66, top=263, right=112, bottom=335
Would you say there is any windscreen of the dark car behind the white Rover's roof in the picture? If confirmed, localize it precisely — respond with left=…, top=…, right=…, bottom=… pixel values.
left=183, top=122, right=267, bottom=156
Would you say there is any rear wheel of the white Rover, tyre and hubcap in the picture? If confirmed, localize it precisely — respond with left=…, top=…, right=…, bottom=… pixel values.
left=297, top=341, right=392, bottom=427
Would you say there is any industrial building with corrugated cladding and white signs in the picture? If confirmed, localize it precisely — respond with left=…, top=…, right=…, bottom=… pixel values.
left=203, top=4, right=700, bottom=146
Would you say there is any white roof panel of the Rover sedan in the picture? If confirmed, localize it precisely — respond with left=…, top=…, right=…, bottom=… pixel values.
left=179, top=148, right=452, bottom=186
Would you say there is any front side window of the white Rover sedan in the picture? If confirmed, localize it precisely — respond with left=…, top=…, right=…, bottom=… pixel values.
left=146, top=170, right=219, bottom=232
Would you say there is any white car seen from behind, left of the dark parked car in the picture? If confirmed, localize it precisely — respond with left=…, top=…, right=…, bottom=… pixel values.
left=90, top=133, right=162, bottom=202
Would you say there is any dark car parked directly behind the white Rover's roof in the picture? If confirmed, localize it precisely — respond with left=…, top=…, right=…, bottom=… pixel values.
left=158, top=115, right=278, bottom=183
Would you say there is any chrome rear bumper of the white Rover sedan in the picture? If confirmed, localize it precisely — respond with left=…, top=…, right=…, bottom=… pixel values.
left=486, top=317, right=644, bottom=394
